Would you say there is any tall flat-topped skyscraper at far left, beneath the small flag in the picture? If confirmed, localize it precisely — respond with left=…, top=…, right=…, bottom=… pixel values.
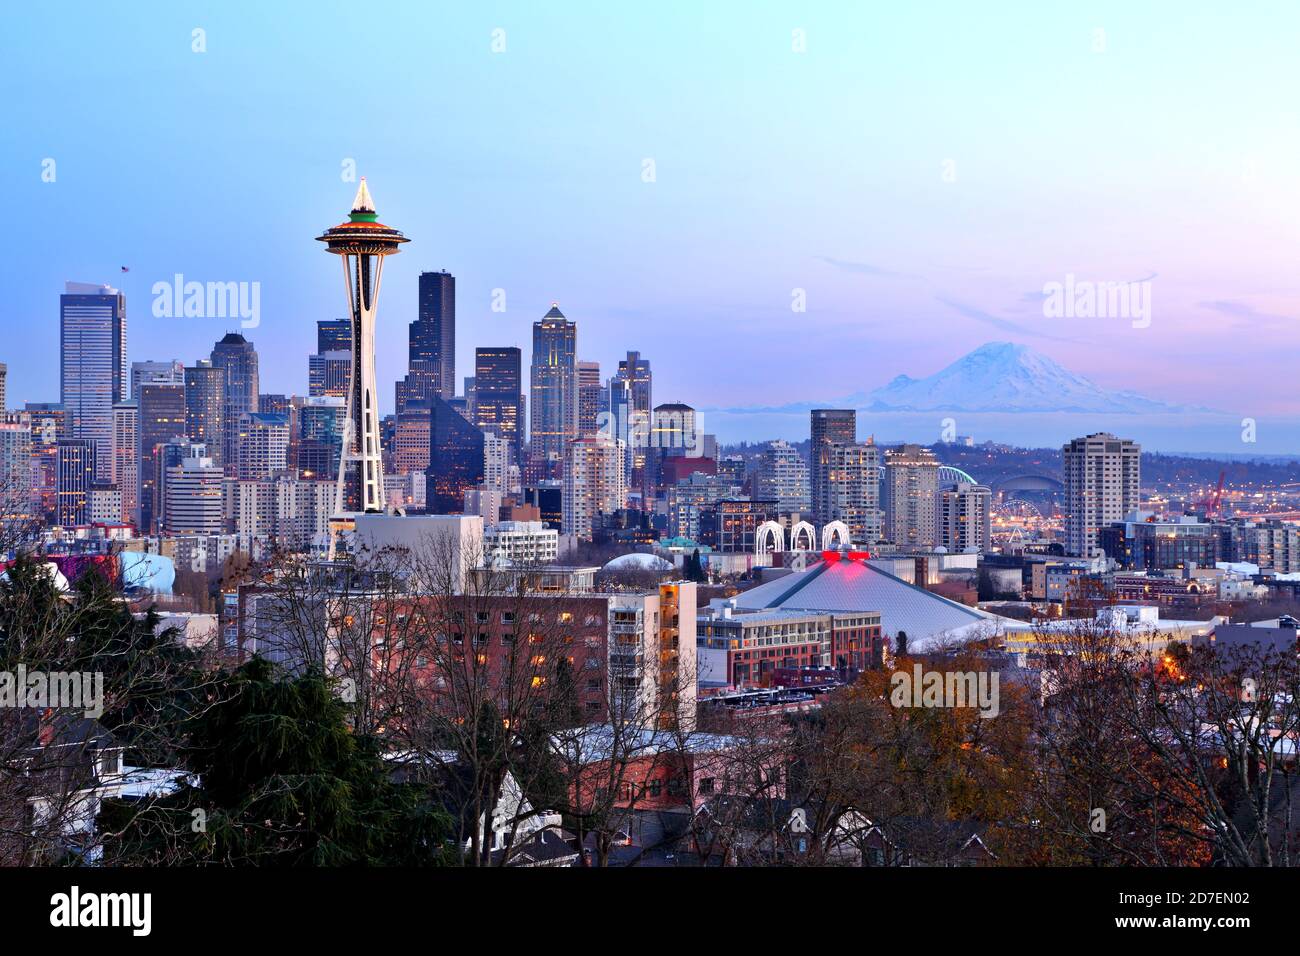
left=59, top=282, right=127, bottom=480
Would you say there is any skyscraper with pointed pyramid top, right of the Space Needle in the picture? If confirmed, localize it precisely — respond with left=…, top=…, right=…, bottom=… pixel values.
left=528, top=303, right=577, bottom=480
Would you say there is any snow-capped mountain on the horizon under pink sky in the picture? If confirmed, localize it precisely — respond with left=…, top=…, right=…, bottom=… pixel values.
left=846, top=342, right=1182, bottom=414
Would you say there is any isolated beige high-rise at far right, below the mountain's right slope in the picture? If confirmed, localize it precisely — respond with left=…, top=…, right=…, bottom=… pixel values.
left=1061, top=432, right=1141, bottom=558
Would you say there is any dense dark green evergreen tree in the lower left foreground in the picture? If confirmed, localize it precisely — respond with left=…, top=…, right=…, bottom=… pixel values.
left=100, top=657, right=451, bottom=866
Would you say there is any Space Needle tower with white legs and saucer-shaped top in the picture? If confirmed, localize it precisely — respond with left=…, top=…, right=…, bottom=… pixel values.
left=316, top=176, right=408, bottom=557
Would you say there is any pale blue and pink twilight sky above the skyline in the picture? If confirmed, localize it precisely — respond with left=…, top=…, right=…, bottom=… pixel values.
left=0, top=0, right=1300, bottom=453
